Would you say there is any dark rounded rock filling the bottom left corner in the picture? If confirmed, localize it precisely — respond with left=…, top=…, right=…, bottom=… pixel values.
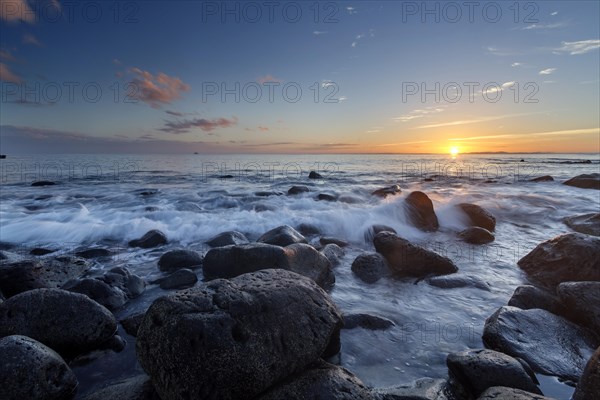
left=0, top=335, right=77, bottom=400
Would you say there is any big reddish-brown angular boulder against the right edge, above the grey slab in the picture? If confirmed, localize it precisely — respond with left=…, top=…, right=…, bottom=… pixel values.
left=518, top=233, right=600, bottom=288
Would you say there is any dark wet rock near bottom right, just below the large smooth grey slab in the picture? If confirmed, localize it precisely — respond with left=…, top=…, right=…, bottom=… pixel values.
left=446, top=349, right=542, bottom=398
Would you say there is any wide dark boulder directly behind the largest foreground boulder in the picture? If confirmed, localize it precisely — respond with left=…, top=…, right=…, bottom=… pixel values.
left=203, top=243, right=335, bottom=288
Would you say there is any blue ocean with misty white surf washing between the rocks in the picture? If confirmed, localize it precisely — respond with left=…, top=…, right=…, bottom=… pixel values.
left=0, top=153, right=600, bottom=398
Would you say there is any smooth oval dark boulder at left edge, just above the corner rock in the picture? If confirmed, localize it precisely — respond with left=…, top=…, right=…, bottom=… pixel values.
left=0, top=289, right=117, bottom=355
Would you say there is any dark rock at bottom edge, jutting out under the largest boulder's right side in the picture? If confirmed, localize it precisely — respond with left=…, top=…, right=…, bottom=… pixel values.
left=256, top=361, right=374, bottom=400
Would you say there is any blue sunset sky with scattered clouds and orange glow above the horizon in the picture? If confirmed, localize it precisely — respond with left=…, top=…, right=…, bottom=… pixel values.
left=0, top=0, right=600, bottom=154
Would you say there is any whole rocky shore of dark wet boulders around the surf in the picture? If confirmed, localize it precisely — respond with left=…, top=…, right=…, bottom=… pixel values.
left=0, top=173, right=600, bottom=400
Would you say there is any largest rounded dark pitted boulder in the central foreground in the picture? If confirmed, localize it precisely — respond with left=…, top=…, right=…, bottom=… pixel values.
left=136, top=269, right=342, bottom=400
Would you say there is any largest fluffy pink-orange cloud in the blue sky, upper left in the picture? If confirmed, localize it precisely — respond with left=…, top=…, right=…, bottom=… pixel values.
left=129, top=68, right=190, bottom=108
